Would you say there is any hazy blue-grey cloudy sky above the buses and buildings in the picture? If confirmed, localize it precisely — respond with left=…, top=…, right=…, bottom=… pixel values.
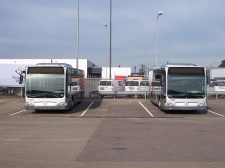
left=0, top=0, right=225, bottom=67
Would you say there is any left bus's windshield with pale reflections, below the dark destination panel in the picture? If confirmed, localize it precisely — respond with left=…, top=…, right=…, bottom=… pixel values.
left=26, top=74, right=65, bottom=98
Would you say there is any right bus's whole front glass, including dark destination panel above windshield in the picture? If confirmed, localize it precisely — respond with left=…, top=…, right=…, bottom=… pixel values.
left=167, top=67, right=206, bottom=98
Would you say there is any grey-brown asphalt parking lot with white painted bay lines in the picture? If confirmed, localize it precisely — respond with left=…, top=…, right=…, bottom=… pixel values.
left=0, top=97, right=225, bottom=168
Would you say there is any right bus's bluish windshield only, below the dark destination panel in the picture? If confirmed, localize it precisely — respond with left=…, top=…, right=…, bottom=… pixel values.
left=167, top=74, right=206, bottom=98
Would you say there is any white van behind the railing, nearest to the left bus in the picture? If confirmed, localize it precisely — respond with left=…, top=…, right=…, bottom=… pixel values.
left=98, top=80, right=124, bottom=98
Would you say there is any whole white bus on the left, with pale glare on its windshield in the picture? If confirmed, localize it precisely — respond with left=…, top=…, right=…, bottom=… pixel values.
left=25, top=63, right=85, bottom=110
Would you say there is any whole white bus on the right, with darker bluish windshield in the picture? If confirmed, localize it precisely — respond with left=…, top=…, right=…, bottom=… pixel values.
left=150, top=64, right=207, bottom=110
